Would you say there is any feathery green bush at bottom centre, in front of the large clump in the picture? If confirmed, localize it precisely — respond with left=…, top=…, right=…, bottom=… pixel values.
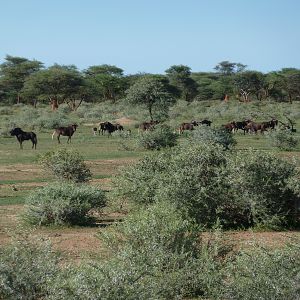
left=47, top=203, right=225, bottom=300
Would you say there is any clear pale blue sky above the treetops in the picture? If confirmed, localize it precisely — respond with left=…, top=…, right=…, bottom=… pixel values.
left=0, top=0, right=300, bottom=74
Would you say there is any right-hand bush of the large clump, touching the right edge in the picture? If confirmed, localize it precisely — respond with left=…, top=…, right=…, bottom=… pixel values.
left=224, top=150, right=300, bottom=229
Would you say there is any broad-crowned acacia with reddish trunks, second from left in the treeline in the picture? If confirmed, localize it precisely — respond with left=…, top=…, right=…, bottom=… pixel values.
left=22, top=65, right=89, bottom=110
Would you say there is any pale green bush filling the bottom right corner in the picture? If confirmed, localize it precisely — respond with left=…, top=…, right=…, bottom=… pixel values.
left=218, top=245, right=300, bottom=300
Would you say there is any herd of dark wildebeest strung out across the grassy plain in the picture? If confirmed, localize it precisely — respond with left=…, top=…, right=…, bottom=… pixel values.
left=10, top=118, right=296, bottom=149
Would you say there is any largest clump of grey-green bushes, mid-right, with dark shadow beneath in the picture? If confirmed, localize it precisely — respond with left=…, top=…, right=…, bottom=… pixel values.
left=113, top=143, right=300, bottom=228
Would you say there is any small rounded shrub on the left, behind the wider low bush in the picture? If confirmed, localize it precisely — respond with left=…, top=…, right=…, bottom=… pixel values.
left=40, top=148, right=92, bottom=182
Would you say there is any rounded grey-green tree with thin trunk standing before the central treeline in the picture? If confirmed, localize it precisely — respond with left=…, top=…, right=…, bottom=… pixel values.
left=126, top=75, right=173, bottom=121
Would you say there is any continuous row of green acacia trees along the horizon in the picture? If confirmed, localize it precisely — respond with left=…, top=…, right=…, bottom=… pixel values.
left=0, top=55, right=300, bottom=110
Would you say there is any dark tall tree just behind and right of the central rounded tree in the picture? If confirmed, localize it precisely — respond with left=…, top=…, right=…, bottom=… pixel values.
left=165, top=65, right=197, bottom=101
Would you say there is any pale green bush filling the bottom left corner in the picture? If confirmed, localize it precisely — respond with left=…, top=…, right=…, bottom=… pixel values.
left=0, top=233, right=59, bottom=300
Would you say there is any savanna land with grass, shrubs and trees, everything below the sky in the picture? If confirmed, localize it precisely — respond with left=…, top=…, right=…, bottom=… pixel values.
left=0, top=56, right=300, bottom=299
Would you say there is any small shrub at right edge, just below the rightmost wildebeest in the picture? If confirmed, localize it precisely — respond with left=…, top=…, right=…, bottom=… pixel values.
left=268, top=130, right=299, bottom=151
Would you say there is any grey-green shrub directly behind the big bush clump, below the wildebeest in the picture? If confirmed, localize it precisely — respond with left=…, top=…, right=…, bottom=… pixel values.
left=191, top=126, right=236, bottom=149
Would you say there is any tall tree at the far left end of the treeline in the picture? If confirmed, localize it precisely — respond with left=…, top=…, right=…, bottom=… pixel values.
left=0, top=55, right=43, bottom=103
